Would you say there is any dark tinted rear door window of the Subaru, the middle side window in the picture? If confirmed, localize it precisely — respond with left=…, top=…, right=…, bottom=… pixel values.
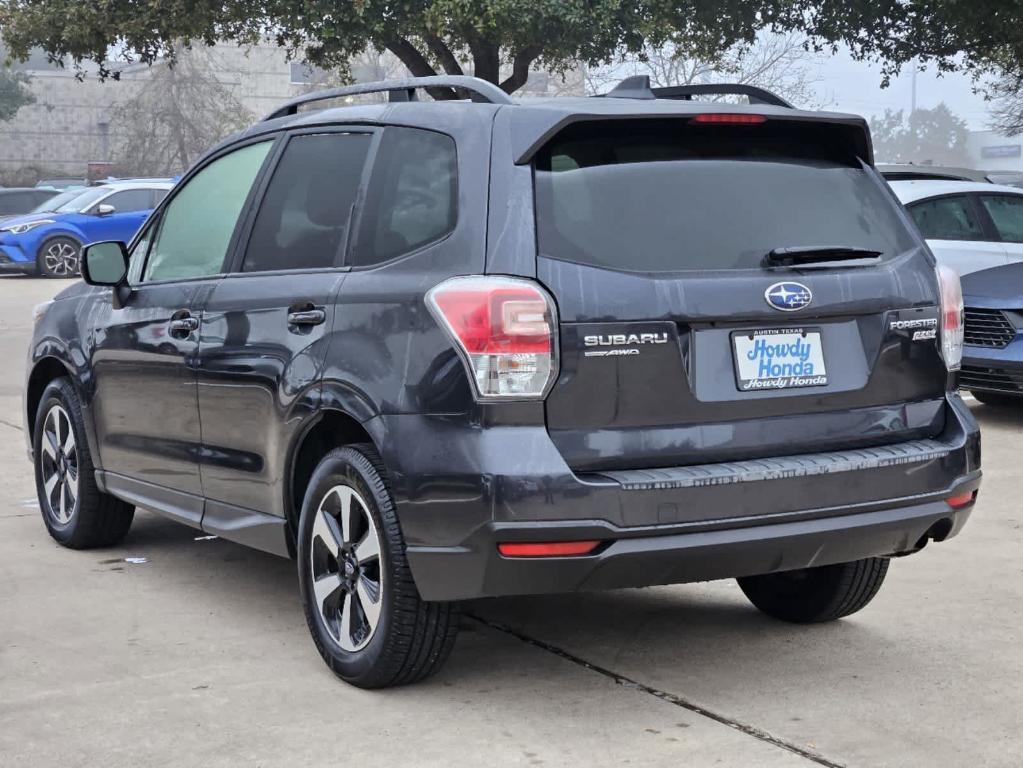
left=241, top=133, right=372, bottom=272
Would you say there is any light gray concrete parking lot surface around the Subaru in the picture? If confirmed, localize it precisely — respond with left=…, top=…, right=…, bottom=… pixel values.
left=0, top=277, right=1023, bottom=768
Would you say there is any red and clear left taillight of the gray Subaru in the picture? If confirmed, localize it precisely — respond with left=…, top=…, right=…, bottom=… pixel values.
left=427, top=276, right=558, bottom=400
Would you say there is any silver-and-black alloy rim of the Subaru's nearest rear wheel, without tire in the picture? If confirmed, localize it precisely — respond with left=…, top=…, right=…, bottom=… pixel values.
left=309, top=486, right=384, bottom=652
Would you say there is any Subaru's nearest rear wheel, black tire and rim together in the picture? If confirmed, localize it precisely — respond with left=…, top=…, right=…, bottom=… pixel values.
left=298, top=445, right=458, bottom=688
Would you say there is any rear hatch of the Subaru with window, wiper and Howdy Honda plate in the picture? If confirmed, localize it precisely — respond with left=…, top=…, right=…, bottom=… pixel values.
left=533, top=112, right=946, bottom=471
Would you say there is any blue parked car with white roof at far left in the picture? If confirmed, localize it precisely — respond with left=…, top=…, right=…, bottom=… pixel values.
left=0, top=182, right=173, bottom=277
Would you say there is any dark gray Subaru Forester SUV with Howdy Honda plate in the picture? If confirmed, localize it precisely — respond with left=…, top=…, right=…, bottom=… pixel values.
left=25, top=78, right=980, bottom=687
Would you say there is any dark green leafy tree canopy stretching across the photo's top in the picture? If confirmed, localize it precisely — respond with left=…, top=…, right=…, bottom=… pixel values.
left=0, top=0, right=1023, bottom=92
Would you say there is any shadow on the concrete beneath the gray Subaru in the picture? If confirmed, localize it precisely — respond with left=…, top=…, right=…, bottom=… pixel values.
left=116, top=511, right=892, bottom=686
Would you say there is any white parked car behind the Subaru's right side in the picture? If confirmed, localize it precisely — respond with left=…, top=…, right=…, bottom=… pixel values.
left=891, top=181, right=1023, bottom=275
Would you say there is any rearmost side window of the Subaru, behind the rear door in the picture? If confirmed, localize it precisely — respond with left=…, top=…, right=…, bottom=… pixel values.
left=350, top=128, right=458, bottom=266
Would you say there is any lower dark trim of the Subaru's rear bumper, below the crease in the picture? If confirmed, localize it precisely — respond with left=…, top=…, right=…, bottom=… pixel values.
left=408, top=482, right=980, bottom=600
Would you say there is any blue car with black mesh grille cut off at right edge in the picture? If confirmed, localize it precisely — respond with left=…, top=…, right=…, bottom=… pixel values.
left=960, top=263, right=1023, bottom=406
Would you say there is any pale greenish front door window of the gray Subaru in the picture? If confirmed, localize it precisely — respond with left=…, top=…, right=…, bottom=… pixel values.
left=142, top=141, right=272, bottom=282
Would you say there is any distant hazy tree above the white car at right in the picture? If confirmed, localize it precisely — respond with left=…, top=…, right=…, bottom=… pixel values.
left=871, top=103, right=969, bottom=166
